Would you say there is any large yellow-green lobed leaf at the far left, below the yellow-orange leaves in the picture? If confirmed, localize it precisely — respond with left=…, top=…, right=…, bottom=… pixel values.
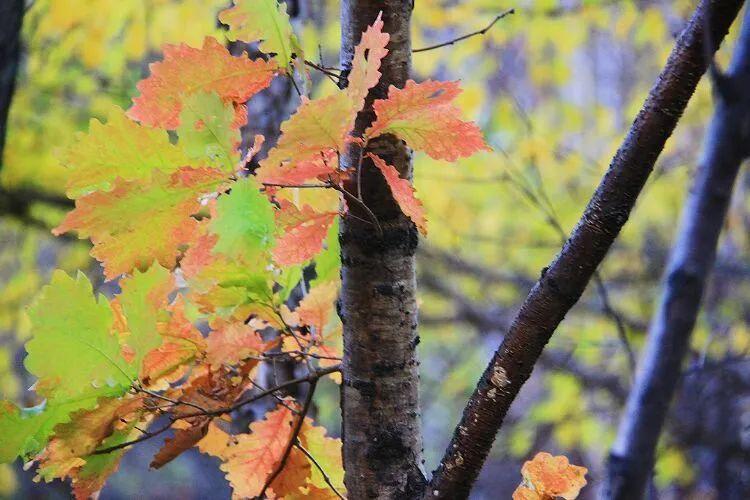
left=25, top=270, right=136, bottom=401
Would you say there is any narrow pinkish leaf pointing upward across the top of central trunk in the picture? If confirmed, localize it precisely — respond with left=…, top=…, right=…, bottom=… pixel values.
left=346, top=12, right=391, bottom=111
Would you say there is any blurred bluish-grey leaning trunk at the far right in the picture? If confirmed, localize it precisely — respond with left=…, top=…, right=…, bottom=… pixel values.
left=604, top=5, right=750, bottom=500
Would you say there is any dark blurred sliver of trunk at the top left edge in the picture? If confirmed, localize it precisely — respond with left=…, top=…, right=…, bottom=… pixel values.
left=0, top=0, right=24, bottom=169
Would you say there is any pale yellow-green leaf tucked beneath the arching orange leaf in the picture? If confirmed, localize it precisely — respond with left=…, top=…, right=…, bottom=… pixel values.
left=177, top=92, right=240, bottom=173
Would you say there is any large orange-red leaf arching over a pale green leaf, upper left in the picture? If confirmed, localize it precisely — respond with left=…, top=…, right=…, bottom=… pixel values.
left=128, top=37, right=278, bottom=129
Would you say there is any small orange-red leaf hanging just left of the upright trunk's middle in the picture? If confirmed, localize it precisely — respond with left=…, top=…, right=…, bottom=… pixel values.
left=273, top=200, right=338, bottom=266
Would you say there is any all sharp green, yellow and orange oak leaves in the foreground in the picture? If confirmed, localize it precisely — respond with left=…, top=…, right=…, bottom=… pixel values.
left=0, top=0, right=581, bottom=498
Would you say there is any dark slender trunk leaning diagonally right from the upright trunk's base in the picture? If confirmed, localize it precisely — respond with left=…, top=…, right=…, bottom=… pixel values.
left=425, top=0, right=742, bottom=500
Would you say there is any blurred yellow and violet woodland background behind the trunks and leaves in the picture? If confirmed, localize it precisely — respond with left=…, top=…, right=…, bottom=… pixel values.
left=0, top=0, right=750, bottom=498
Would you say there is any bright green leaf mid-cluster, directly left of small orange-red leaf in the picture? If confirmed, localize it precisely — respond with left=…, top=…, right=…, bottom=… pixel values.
left=211, top=177, right=275, bottom=260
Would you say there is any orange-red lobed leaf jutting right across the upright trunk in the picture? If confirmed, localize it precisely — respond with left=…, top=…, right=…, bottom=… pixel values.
left=365, top=80, right=490, bottom=161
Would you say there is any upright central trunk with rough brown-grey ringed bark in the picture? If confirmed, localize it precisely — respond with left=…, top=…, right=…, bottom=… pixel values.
left=339, top=0, right=425, bottom=499
